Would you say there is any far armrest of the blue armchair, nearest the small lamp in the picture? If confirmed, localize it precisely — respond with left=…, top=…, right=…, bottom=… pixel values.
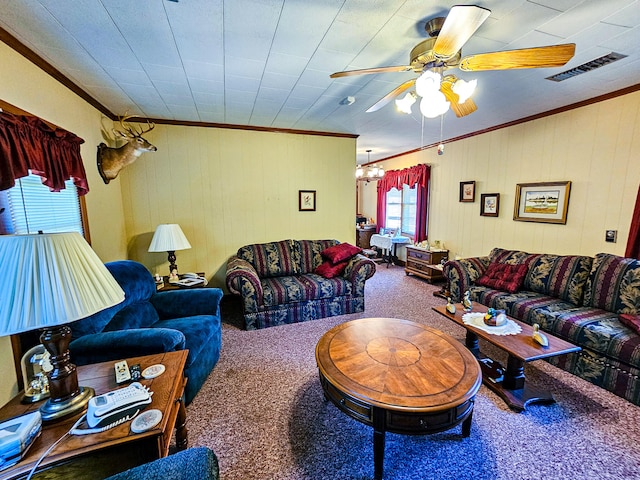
left=150, top=288, right=222, bottom=320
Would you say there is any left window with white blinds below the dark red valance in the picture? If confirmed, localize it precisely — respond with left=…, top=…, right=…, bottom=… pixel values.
left=0, top=174, right=86, bottom=237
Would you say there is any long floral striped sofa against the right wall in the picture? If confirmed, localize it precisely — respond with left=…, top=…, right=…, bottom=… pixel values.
left=443, top=248, right=640, bottom=405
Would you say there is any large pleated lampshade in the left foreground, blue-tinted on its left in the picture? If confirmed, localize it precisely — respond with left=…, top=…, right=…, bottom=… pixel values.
left=0, top=232, right=124, bottom=335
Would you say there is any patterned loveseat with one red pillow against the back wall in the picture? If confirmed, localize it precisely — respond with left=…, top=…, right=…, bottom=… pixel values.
left=226, top=240, right=376, bottom=330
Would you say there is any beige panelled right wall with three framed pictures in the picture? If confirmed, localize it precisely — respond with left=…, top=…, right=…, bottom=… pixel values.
left=362, top=92, right=640, bottom=258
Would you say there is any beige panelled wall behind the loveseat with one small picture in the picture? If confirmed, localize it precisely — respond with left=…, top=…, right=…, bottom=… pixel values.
left=121, top=125, right=356, bottom=288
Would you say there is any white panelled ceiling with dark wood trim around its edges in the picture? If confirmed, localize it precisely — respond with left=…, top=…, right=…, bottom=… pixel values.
left=0, top=0, right=640, bottom=162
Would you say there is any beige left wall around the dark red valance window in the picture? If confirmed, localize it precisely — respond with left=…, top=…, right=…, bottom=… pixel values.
left=0, top=42, right=126, bottom=405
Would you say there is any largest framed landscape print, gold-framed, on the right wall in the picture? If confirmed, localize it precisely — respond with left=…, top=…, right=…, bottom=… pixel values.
left=513, top=181, right=571, bottom=224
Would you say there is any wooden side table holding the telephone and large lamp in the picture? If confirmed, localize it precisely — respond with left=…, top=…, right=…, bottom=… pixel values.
left=0, top=350, right=188, bottom=480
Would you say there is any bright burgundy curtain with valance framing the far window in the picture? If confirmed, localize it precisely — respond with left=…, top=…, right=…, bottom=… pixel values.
left=376, top=163, right=431, bottom=242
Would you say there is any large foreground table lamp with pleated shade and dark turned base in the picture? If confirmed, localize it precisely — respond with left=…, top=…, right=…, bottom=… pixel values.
left=0, top=232, right=124, bottom=421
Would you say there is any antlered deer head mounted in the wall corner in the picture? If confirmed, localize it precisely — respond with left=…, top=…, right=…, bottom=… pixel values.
left=98, top=115, right=157, bottom=183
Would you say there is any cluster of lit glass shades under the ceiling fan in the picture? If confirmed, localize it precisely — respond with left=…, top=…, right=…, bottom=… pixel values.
left=396, top=70, right=478, bottom=118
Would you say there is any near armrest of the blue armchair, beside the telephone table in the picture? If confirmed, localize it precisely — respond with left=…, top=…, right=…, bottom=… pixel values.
left=69, top=326, right=186, bottom=365
